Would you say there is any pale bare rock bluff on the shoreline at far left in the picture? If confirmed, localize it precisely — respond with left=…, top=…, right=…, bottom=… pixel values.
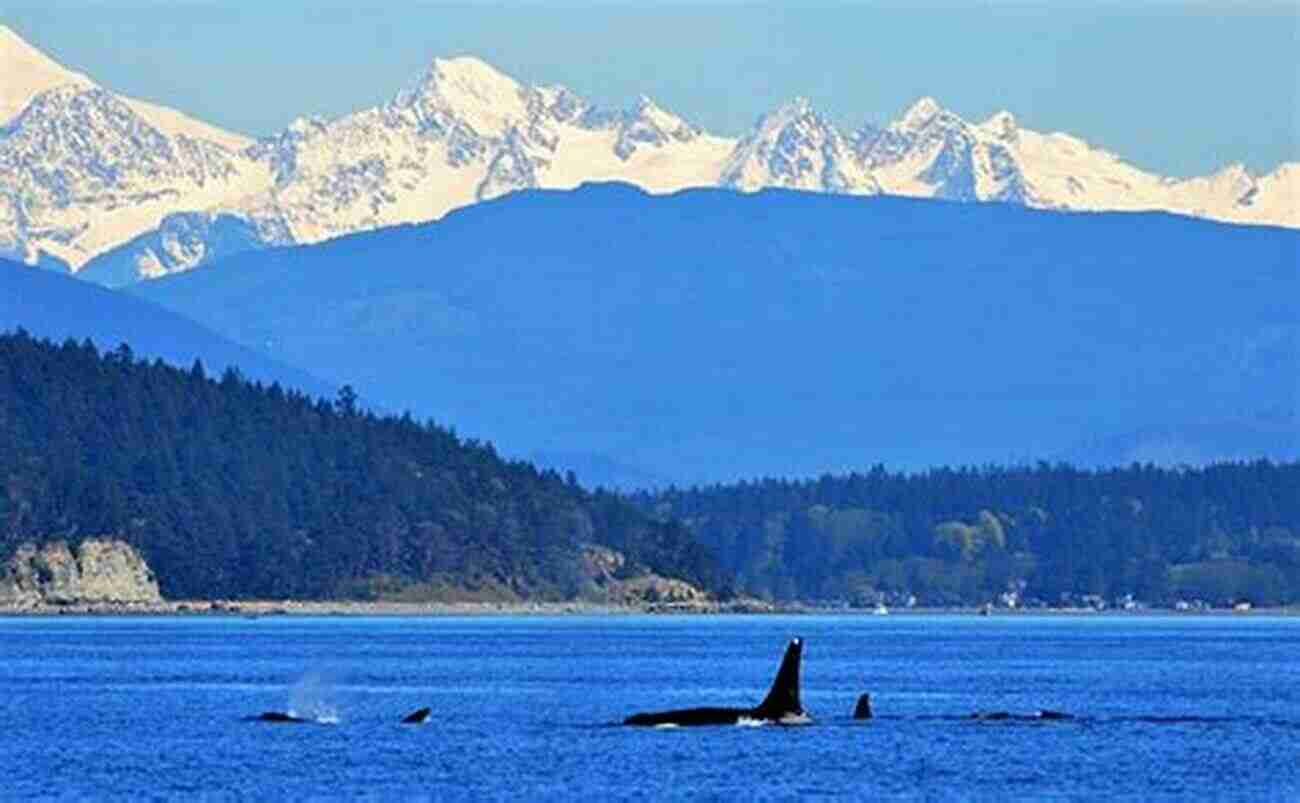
left=0, top=539, right=163, bottom=608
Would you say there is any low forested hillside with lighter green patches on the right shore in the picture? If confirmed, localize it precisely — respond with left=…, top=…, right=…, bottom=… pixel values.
left=637, top=461, right=1300, bottom=604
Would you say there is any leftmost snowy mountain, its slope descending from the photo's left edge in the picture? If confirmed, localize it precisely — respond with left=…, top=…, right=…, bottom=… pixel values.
left=0, top=27, right=265, bottom=269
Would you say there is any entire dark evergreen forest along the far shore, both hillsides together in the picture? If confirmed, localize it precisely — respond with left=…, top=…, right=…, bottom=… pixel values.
left=0, top=324, right=1300, bottom=605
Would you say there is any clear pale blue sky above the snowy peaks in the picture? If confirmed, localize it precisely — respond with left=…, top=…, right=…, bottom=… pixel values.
left=0, top=0, right=1300, bottom=175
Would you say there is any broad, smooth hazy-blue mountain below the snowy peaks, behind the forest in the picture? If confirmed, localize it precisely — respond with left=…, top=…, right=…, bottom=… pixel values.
left=119, top=185, right=1300, bottom=483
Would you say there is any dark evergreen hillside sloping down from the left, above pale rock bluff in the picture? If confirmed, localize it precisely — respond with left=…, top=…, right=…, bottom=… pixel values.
left=0, top=330, right=716, bottom=599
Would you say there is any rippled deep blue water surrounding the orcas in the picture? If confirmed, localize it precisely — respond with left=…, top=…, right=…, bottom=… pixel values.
left=0, top=616, right=1300, bottom=800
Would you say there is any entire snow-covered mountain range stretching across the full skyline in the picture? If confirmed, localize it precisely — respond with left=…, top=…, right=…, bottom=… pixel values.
left=0, top=26, right=1300, bottom=283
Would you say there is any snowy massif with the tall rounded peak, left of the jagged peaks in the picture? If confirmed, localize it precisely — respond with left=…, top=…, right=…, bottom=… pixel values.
left=218, top=57, right=733, bottom=243
